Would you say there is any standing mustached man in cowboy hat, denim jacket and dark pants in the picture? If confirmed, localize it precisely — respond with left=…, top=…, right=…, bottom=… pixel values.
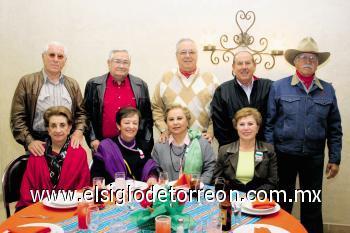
left=265, top=37, right=343, bottom=233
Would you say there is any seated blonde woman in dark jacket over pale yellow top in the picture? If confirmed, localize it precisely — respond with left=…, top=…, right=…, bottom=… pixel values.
left=214, top=107, right=278, bottom=192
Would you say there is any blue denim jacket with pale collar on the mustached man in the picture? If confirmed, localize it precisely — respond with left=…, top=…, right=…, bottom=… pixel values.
left=265, top=75, right=343, bottom=164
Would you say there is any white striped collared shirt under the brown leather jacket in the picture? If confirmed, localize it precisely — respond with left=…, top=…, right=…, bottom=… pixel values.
left=33, top=70, right=72, bottom=131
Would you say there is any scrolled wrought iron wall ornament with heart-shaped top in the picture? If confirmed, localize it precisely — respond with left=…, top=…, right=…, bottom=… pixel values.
left=203, top=10, right=283, bottom=69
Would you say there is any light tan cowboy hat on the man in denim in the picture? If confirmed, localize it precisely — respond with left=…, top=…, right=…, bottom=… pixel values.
left=284, top=37, right=331, bottom=66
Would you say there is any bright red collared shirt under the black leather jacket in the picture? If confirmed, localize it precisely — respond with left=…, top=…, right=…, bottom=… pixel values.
left=102, top=74, right=136, bottom=138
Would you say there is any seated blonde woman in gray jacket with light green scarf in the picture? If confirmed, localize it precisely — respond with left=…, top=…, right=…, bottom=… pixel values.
left=152, top=104, right=215, bottom=183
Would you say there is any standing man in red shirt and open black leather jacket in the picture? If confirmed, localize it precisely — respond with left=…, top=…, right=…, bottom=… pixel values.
left=84, top=50, right=154, bottom=155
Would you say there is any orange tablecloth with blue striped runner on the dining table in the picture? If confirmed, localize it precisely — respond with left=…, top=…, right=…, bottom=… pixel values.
left=0, top=187, right=307, bottom=233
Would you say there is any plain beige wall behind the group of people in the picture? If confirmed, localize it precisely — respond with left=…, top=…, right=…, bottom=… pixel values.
left=0, top=0, right=350, bottom=224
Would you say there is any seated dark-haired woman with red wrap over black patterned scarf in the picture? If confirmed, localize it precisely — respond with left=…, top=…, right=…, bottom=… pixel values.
left=16, top=106, right=90, bottom=210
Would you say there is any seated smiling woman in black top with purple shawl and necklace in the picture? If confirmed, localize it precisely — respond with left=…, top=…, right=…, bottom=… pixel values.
left=91, top=107, right=159, bottom=184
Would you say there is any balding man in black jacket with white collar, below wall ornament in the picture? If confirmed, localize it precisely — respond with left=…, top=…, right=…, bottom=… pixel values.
left=211, top=51, right=272, bottom=147
